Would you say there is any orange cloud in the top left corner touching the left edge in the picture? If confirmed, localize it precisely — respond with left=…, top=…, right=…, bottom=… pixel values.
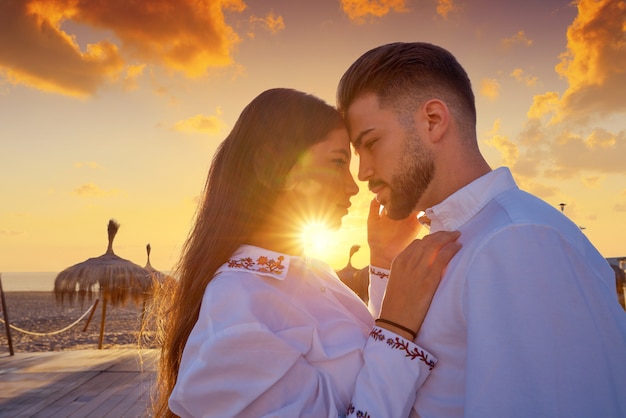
left=0, top=1, right=123, bottom=97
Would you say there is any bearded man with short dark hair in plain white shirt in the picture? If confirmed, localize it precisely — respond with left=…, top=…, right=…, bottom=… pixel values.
left=337, top=43, right=626, bottom=418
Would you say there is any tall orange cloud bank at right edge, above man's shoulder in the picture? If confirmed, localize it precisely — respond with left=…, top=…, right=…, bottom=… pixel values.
left=502, top=0, right=626, bottom=187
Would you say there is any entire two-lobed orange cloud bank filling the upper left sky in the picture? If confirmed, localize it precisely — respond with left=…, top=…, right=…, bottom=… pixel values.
left=0, top=0, right=246, bottom=96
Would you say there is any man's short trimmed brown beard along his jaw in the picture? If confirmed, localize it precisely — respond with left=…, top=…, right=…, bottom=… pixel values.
left=385, top=131, right=435, bottom=219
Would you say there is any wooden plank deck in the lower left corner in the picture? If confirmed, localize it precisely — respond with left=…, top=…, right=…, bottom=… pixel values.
left=0, top=349, right=158, bottom=418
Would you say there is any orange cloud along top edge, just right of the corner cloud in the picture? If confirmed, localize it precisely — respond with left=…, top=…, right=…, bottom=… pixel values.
left=77, top=0, right=246, bottom=77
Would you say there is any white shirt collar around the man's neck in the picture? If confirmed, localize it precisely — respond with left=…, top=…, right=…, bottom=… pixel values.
left=426, top=167, right=517, bottom=233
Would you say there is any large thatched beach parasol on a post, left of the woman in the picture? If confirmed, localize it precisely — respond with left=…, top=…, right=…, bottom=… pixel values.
left=54, top=219, right=152, bottom=348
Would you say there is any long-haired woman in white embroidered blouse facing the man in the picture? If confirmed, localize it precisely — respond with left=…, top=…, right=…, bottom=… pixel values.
left=156, top=89, right=456, bottom=417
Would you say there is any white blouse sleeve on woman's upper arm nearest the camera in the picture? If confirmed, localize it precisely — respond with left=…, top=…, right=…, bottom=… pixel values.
left=170, top=323, right=338, bottom=418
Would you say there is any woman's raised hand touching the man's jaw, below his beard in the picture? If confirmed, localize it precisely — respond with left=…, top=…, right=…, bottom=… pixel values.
left=367, top=198, right=422, bottom=269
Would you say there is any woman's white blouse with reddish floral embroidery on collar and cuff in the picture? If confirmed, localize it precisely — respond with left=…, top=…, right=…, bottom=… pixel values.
left=169, top=245, right=436, bottom=418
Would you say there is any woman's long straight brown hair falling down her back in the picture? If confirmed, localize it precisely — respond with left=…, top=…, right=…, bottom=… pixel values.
left=154, top=89, right=343, bottom=417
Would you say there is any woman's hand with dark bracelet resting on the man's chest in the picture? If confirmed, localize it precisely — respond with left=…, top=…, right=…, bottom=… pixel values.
left=378, top=231, right=461, bottom=340
